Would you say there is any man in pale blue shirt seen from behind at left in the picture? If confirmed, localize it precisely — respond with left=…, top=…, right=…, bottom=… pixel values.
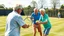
left=5, top=5, right=29, bottom=36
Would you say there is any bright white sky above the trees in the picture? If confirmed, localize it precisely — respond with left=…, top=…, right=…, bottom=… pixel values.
left=0, top=0, right=64, bottom=8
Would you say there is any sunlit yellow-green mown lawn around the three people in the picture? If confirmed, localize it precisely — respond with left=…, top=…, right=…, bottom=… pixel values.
left=0, top=16, right=64, bottom=36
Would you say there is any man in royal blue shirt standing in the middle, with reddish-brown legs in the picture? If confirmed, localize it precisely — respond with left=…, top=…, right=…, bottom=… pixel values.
left=31, top=8, right=42, bottom=36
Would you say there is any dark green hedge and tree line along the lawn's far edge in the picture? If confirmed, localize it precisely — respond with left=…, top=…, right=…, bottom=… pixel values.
left=0, top=5, right=64, bottom=17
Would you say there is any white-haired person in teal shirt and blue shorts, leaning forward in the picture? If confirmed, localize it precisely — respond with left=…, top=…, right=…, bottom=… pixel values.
left=37, top=9, right=51, bottom=36
